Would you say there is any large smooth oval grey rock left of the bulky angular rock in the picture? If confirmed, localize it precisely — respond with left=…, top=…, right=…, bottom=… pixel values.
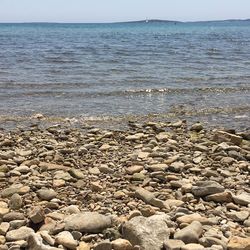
left=64, top=212, right=112, bottom=233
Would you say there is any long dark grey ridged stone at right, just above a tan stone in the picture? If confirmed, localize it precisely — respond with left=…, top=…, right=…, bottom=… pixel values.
left=192, top=181, right=225, bottom=197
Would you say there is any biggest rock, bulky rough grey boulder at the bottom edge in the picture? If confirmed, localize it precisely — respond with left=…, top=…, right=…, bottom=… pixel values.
left=122, top=214, right=170, bottom=250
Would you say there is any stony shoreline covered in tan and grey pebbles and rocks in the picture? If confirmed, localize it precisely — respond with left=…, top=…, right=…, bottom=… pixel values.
left=0, top=117, right=250, bottom=250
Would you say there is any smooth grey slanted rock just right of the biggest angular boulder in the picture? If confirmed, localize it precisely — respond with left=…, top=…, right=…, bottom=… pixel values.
left=174, top=221, right=203, bottom=244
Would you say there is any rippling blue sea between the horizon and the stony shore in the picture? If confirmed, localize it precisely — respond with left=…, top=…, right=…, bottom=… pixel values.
left=0, top=20, right=250, bottom=129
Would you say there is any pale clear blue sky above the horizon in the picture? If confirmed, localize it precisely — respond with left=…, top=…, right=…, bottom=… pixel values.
left=0, top=0, right=250, bottom=22
